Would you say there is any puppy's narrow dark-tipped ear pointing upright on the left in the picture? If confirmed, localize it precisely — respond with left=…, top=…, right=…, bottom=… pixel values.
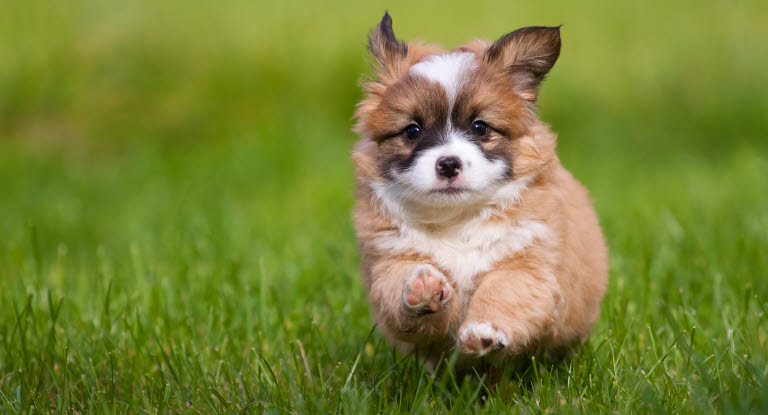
left=368, top=12, right=408, bottom=80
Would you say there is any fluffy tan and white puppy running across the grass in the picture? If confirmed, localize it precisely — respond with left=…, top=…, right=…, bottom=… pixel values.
left=352, top=13, right=607, bottom=364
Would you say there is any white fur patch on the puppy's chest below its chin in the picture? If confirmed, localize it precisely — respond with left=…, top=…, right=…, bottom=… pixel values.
left=376, top=219, right=549, bottom=292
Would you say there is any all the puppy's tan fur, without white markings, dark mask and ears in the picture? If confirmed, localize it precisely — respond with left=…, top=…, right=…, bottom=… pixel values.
left=352, top=18, right=607, bottom=368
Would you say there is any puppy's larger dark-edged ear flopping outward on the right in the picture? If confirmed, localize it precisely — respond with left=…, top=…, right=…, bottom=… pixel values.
left=484, top=26, right=560, bottom=102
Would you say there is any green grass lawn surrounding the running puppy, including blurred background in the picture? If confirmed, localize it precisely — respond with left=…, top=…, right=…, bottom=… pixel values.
left=0, top=0, right=768, bottom=414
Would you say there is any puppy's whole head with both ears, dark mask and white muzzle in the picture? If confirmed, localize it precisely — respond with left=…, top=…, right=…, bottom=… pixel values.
left=354, top=14, right=560, bottom=205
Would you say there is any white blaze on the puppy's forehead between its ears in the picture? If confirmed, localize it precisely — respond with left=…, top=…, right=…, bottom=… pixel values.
left=411, top=52, right=477, bottom=103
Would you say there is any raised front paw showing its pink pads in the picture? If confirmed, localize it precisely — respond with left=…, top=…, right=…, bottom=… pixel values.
left=403, top=264, right=453, bottom=314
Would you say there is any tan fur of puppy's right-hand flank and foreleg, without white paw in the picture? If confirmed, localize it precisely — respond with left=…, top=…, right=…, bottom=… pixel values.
left=464, top=163, right=607, bottom=353
